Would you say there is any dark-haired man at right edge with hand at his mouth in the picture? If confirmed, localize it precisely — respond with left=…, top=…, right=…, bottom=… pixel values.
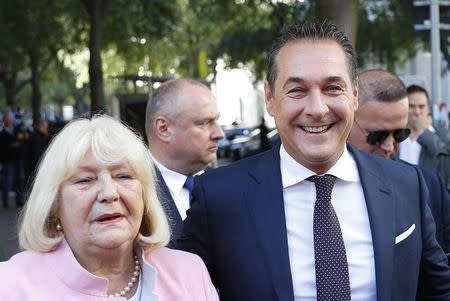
left=399, top=85, right=450, bottom=191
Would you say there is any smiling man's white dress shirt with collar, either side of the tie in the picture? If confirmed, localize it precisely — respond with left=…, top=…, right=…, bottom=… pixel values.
left=280, top=145, right=377, bottom=301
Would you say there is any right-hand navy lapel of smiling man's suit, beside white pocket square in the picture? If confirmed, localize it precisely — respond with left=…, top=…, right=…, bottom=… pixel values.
left=349, top=147, right=395, bottom=300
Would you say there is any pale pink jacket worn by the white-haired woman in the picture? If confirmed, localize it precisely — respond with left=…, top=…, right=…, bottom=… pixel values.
left=0, top=241, right=219, bottom=301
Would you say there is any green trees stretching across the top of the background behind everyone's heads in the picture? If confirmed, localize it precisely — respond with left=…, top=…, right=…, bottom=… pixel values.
left=0, top=0, right=436, bottom=116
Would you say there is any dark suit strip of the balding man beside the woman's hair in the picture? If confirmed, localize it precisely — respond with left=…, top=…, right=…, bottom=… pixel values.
left=155, top=166, right=183, bottom=248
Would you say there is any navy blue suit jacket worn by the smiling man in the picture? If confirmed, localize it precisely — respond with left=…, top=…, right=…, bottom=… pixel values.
left=178, top=147, right=450, bottom=301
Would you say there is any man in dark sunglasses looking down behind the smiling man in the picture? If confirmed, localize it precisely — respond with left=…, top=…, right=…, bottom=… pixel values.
left=348, top=69, right=450, bottom=253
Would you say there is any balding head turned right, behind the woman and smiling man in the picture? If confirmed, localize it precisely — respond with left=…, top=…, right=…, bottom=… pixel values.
left=146, top=79, right=223, bottom=175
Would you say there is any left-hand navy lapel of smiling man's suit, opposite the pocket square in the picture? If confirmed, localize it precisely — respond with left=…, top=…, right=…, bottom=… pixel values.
left=245, top=147, right=294, bottom=301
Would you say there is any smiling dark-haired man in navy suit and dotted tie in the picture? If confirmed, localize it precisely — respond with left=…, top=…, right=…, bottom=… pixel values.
left=178, top=22, right=450, bottom=301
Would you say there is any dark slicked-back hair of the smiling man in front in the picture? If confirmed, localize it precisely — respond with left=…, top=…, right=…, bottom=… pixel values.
left=266, top=20, right=356, bottom=91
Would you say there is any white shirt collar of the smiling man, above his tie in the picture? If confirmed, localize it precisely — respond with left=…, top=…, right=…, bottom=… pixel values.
left=280, top=144, right=359, bottom=188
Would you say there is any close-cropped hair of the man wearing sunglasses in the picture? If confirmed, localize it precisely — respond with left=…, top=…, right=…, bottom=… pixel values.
left=358, top=69, right=408, bottom=104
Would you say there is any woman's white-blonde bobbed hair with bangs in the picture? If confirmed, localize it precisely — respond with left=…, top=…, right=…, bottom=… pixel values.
left=19, top=115, right=170, bottom=252
